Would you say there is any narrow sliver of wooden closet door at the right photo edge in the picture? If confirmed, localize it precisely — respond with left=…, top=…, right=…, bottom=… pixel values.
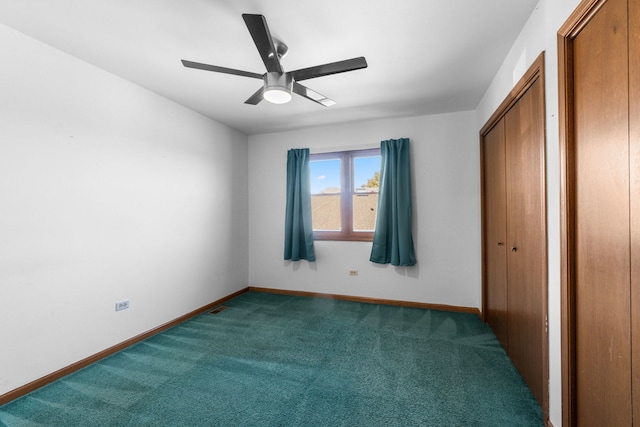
left=629, top=0, right=640, bottom=418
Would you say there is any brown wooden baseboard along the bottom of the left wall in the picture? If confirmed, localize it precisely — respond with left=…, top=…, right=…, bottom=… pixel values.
left=0, top=288, right=249, bottom=406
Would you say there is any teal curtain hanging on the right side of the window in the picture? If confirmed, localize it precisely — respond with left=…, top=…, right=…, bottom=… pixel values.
left=369, top=138, right=416, bottom=266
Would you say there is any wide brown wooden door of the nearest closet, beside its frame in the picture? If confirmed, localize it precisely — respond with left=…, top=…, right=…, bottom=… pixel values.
left=573, top=0, right=632, bottom=426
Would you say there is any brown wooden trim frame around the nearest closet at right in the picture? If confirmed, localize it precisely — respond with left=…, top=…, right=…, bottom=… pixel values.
left=558, top=0, right=607, bottom=426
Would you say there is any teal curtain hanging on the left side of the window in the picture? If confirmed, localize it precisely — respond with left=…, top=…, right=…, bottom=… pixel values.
left=284, top=148, right=316, bottom=261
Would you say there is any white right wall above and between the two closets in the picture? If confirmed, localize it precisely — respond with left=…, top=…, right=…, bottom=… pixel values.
left=477, top=0, right=580, bottom=427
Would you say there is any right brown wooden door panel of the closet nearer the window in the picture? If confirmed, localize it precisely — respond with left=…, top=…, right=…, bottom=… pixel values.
left=504, top=79, right=547, bottom=406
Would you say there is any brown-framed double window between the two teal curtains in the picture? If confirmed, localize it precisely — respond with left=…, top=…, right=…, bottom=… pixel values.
left=309, top=148, right=380, bottom=241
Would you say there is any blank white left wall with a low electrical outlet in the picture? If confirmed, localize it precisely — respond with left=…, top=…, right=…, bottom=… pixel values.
left=0, top=25, right=248, bottom=394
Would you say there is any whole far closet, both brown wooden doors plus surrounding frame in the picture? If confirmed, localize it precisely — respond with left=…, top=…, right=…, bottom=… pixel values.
left=480, top=54, right=549, bottom=416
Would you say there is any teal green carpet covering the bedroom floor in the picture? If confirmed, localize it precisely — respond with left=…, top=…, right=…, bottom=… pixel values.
left=0, top=292, right=543, bottom=427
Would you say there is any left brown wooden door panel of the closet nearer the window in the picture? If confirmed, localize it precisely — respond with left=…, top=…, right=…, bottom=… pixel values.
left=482, top=119, right=509, bottom=353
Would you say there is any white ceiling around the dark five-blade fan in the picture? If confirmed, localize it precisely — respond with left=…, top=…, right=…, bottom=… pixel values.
left=0, top=0, right=538, bottom=134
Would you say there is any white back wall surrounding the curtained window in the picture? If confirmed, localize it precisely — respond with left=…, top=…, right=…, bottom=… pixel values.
left=249, top=112, right=481, bottom=308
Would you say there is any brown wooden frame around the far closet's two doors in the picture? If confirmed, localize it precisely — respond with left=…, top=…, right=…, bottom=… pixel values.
left=480, top=51, right=549, bottom=424
